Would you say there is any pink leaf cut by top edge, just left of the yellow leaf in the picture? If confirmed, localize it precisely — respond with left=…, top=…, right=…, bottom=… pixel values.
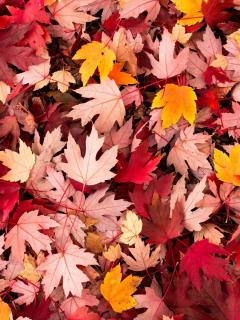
left=120, top=0, right=160, bottom=21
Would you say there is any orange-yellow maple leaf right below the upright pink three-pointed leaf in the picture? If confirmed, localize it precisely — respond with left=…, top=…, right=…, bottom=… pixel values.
left=152, top=84, right=197, bottom=129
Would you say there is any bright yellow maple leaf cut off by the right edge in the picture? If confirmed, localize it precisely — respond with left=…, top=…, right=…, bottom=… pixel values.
left=214, top=144, right=240, bottom=186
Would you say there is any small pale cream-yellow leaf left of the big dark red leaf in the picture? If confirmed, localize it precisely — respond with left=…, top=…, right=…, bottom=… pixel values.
left=119, top=210, right=142, bottom=246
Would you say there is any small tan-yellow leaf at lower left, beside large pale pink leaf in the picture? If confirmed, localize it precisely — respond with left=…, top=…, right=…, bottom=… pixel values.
left=19, top=254, right=41, bottom=283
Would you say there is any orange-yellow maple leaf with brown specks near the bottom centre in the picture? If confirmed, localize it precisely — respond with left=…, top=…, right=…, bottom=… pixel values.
left=100, top=264, right=142, bottom=313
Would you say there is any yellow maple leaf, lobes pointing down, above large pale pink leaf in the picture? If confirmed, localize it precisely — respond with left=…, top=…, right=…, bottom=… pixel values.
left=73, top=41, right=116, bottom=86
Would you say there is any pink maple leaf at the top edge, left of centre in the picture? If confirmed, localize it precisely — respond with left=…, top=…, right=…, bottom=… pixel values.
left=48, top=0, right=96, bottom=29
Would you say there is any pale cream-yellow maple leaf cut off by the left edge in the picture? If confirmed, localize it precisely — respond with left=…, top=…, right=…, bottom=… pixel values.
left=0, top=139, right=35, bottom=182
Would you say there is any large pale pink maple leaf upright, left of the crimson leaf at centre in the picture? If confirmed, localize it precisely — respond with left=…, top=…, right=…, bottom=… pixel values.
left=58, top=126, right=117, bottom=185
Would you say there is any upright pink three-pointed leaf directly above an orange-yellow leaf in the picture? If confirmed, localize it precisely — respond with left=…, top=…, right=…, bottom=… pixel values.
left=147, top=29, right=189, bottom=79
